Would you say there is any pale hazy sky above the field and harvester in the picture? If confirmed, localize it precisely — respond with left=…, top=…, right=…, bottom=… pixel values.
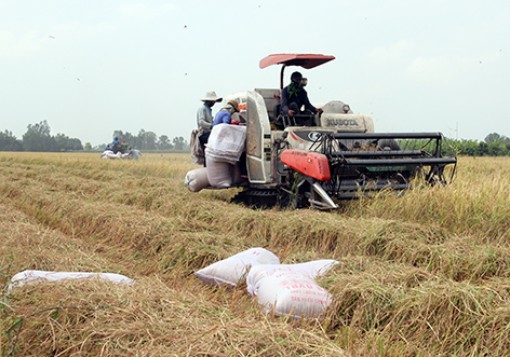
left=0, top=0, right=510, bottom=145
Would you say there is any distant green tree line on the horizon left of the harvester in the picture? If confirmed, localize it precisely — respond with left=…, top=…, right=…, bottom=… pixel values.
left=0, top=120, right=189, bottom=152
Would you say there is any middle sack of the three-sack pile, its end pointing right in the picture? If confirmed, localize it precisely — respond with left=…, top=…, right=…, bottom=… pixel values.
left=246, top=259, right=338, bottom=296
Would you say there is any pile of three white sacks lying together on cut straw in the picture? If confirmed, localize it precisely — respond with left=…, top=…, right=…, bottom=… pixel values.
left=195, top=248, right=338, bottom=318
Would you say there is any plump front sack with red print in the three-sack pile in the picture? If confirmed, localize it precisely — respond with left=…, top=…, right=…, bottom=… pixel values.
left=253, top=270, right=333, bottom=318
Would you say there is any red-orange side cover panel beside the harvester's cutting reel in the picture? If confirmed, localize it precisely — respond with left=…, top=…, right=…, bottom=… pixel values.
left=280, top=149, right=331, bottom=181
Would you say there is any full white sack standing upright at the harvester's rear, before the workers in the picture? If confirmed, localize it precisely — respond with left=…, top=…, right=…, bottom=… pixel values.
left=205, top=124, right=246, bottom=165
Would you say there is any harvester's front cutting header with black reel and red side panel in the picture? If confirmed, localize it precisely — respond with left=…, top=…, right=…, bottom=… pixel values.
left=278, top=133, right=457, bottom=210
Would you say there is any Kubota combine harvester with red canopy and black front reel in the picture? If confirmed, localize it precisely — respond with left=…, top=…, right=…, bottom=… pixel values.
left=189, top=54, right=457, bottom=209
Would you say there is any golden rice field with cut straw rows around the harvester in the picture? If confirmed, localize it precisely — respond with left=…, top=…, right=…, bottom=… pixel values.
left=0, top=153, right=510, bottom=356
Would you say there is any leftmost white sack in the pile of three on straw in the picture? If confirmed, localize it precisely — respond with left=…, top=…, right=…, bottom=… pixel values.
left=195, top=248, right=280, bottom=286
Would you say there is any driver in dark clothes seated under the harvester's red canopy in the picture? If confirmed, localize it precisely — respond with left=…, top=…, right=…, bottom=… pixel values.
left=281, top=71, right=322, bottom=125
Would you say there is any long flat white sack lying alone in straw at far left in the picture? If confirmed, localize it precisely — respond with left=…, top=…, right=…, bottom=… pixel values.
left=7, top=270, right=134, bottom=291
